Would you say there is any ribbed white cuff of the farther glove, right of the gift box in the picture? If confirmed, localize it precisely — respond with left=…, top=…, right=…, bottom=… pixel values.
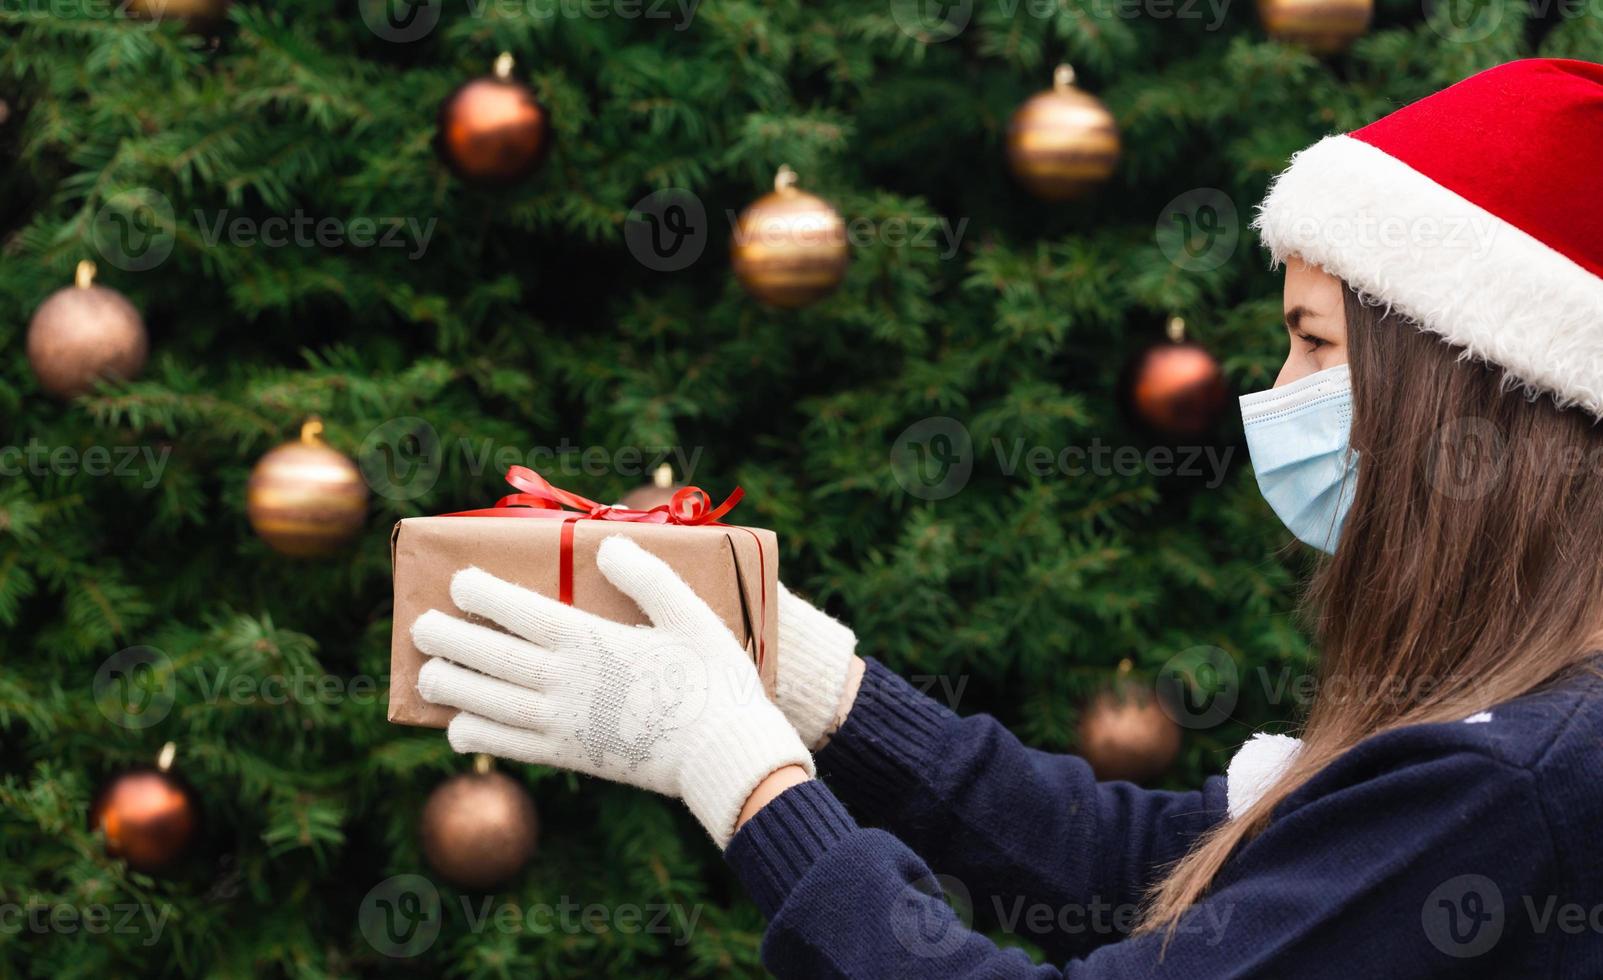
left=774, top=582, right=858, bottom=749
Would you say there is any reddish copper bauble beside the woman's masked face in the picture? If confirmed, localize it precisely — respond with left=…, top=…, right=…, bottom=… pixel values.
left=1129, top=321, right=1230, bottom=438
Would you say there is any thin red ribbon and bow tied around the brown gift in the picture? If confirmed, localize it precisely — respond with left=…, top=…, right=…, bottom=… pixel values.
left=442, top=467, right=768, bottom=669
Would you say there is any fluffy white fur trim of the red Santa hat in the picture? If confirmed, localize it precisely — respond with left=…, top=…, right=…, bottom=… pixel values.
left=1252, top=136, right=1603, bottom=417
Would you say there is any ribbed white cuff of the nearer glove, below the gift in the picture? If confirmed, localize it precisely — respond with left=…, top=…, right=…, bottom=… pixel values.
left=680, top=698, right=818, bottom=850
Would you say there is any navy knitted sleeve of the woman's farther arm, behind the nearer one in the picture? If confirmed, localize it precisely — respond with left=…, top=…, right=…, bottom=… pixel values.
left=818, top=661, right=1225, bottom=958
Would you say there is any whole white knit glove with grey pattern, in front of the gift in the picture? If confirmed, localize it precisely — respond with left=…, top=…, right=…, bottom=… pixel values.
left=412, top=537, right=813, bottom=847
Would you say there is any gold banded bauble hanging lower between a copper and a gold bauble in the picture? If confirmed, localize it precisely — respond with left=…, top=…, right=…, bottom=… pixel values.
left=729, top=167, right=848, bottom=310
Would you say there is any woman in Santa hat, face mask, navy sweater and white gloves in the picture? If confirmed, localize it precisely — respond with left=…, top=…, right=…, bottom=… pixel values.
left=403, top=61, right=1603, bottom=978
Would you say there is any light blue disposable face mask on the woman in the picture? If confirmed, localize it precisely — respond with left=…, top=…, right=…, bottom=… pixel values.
left=1241, top=364, right=1358, bottom=555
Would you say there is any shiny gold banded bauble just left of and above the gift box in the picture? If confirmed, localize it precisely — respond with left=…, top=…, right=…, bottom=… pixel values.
left=245, top=419, right=367, bottom=558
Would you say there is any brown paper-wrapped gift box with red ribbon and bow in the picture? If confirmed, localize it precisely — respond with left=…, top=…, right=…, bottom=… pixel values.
left=390, top=467, right=779, bottom=728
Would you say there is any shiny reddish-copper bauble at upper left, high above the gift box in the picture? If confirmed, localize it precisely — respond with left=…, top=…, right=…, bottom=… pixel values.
left=439, top=55, right=551, bottom=184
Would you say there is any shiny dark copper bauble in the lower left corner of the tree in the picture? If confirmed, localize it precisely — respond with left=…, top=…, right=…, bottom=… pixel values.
left=90, top=768, right=199, bottom=873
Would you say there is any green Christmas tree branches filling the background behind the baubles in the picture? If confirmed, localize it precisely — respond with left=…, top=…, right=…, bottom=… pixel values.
left=0, top=0, right=1603, bottom=977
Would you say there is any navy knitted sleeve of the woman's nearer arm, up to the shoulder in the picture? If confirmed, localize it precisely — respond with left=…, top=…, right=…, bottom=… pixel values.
left=726, top=751, right=1558, bottom=980
